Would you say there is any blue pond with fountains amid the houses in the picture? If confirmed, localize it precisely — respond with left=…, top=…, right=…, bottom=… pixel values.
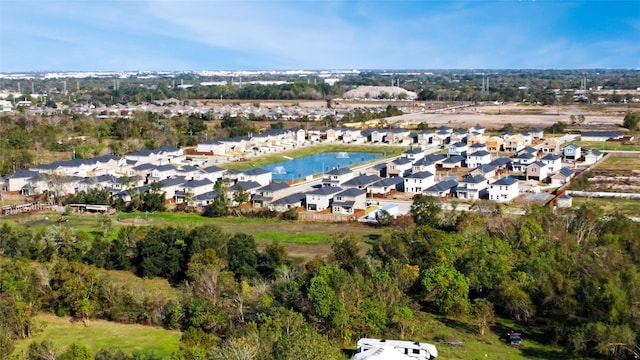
left=261, top=151, right=384, bottom=181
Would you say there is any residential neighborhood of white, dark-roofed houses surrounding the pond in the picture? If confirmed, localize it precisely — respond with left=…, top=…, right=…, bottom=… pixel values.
left=3, top=121, right=613, bottom=219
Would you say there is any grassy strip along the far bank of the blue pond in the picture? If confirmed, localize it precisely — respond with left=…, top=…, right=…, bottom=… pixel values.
left=220, top=144, right=407, bottom=170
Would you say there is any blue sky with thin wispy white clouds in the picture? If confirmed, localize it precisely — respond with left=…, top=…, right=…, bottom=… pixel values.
left=0, top=0, right=640, bottom=72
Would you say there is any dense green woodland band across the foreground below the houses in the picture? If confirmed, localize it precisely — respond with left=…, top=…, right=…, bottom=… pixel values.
left=0, top=198, right=640, bottom=359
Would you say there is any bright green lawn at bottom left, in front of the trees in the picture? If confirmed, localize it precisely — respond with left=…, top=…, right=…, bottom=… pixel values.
left=14, top=313, right=181, bottom=359
